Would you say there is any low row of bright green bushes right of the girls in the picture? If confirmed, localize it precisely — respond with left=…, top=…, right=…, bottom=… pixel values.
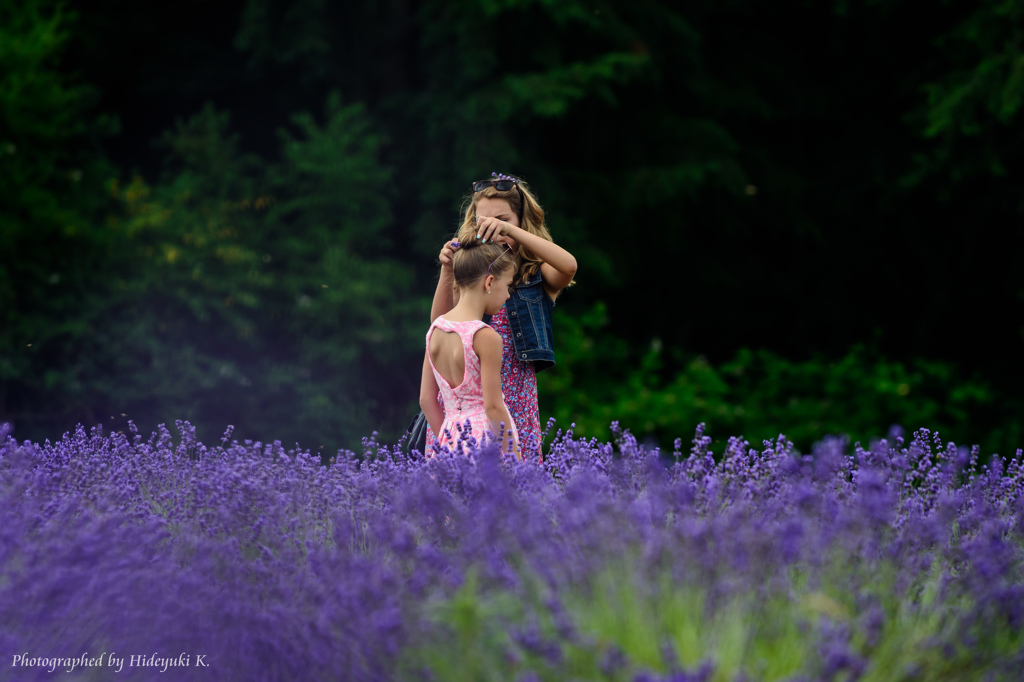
left=539, top=304, right=1011, bottom=456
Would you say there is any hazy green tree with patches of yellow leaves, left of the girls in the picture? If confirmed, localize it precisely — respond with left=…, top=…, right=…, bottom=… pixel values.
left=93, top=106, right=273, bottom=436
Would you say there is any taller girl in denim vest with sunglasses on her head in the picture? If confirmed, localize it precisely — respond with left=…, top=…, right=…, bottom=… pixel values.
left=430, top=173, right=577, bottom=456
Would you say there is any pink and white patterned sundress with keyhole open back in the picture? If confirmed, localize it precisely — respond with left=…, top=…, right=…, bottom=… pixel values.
left=427, top=315, right=519, bottom=450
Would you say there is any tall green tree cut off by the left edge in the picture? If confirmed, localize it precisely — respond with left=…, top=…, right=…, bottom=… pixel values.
left=0, top=0, right=112, bottom=427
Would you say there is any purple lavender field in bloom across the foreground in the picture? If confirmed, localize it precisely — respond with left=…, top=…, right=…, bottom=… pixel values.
left=0, top=423, right=1024, bottom=682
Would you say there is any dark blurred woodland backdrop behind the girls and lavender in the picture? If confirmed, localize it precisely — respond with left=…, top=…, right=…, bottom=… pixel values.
left=0, top=0, right=1024, bottom=453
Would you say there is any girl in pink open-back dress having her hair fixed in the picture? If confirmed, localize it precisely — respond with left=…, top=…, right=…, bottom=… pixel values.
left=420, top=240, right=521, bottom=457
